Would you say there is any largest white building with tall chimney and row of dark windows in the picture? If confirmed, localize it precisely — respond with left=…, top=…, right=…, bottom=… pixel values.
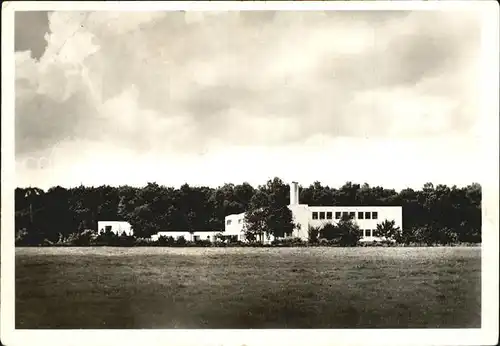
left=224, top=182, right=403, bottom=241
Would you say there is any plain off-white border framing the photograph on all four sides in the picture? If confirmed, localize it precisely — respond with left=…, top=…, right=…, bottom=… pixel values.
left=0, top=1, right=499, bottom=346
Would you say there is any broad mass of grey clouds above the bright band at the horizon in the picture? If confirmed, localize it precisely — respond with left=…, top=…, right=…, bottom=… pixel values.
left=16, top=11, right=480, bottom=166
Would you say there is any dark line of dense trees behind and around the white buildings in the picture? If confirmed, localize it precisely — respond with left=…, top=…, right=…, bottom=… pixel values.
left=15, top=178, right=481, bottom=245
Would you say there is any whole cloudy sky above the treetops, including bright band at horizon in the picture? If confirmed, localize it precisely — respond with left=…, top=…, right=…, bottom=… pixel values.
left=15, top=11, right=482, bottom=190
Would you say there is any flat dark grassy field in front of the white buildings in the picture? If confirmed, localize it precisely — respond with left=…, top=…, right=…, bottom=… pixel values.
left=16, top=247, right=481, bottom=328
